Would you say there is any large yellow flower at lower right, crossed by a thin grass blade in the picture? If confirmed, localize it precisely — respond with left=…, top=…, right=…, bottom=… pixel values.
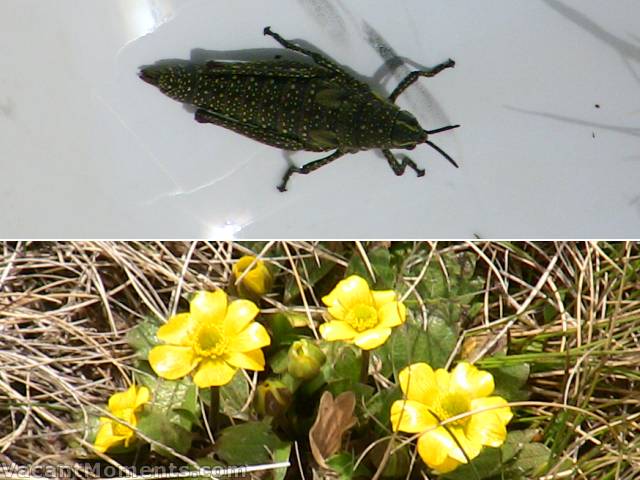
left=391, top=362, right=513, bottom=473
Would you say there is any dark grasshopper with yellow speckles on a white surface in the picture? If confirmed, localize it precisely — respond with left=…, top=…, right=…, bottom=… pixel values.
left=140, top=27, right=459, bottom=192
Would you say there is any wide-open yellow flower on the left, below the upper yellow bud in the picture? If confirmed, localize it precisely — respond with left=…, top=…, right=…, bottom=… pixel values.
left=149, top=290, right=271, bottom=388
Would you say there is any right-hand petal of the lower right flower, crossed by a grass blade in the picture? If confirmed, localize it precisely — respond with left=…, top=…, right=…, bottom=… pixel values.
left=466, top=397, right=513, bottom=447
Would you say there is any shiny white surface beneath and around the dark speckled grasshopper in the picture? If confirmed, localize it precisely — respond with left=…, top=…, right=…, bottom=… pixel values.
left=0, top=0, right=640, bottom=238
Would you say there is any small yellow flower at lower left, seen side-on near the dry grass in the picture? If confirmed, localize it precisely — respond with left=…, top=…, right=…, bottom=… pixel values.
left=94, top=385, right=150, bottom=452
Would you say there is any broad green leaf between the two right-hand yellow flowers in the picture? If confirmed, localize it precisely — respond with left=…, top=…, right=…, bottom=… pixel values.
left=374, top=317, right=457, bottom=377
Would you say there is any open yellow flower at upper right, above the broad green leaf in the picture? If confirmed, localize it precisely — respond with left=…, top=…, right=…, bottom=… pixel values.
left=320, top=275, right=406, bottom=350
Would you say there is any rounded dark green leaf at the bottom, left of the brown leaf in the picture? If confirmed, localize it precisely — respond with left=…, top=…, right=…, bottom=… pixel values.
left=216, top=422, right=289, bottom=465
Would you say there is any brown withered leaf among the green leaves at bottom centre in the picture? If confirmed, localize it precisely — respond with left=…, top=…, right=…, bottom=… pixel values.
left=309, top=392, right=356, bottom=468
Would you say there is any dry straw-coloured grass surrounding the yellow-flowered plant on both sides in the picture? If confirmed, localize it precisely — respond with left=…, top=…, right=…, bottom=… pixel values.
left=0, top=242, right=640, bottom=480
